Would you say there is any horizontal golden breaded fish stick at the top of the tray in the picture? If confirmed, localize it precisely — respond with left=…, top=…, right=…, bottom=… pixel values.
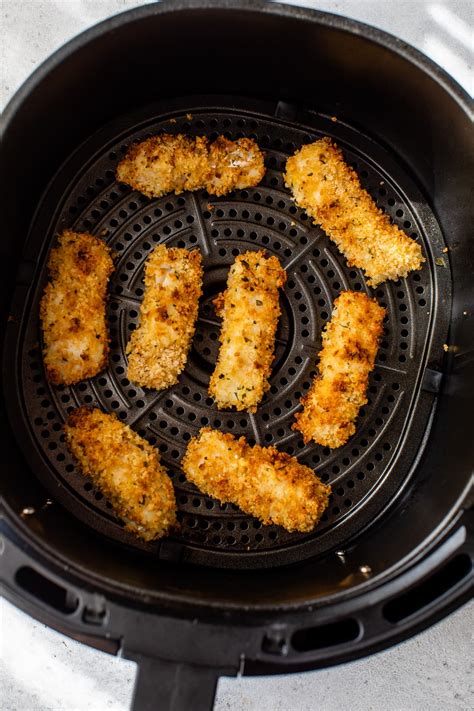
left=116, top=133, right=265, bottom=197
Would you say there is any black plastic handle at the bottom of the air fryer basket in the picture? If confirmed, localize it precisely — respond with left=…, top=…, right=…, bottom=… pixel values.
left=132, top=657, right=219, bottom=711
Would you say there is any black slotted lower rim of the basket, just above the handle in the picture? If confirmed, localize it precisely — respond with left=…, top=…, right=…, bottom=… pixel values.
left=0, top=511, right=474, bottom=676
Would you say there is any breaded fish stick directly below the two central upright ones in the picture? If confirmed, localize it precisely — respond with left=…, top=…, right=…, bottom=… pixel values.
left=181, top=427, right=331, bottom=533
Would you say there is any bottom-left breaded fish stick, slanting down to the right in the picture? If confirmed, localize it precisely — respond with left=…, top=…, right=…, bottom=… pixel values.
left=64, top=407, right=177, bottom=541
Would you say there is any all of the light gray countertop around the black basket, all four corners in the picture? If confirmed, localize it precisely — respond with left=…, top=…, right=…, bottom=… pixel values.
left=0, top=0, right=474, bottom=711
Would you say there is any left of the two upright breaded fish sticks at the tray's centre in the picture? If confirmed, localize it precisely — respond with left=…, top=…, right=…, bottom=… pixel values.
left=127, top=245, right=202, bottom=390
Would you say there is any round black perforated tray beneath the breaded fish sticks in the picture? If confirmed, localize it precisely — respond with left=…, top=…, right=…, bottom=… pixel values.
left=6, top=99, right=450, bottom=568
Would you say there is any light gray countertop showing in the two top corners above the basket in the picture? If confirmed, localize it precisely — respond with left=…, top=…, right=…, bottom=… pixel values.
left=0, top=0, right=474, bottom=107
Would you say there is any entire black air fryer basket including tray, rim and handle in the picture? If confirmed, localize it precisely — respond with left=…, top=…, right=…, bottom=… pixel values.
left=0, top=1, right=474, bottom=709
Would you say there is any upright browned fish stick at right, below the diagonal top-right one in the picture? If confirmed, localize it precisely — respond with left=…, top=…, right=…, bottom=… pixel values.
left=293, top=291, right=385, bottom=447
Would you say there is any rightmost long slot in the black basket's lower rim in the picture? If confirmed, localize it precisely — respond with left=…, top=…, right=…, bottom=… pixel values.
left=383, top=553, right=472, bottom=624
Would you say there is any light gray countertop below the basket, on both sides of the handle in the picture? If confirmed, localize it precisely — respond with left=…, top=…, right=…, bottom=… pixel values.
left=0, top=602, right=474, bottom=711
